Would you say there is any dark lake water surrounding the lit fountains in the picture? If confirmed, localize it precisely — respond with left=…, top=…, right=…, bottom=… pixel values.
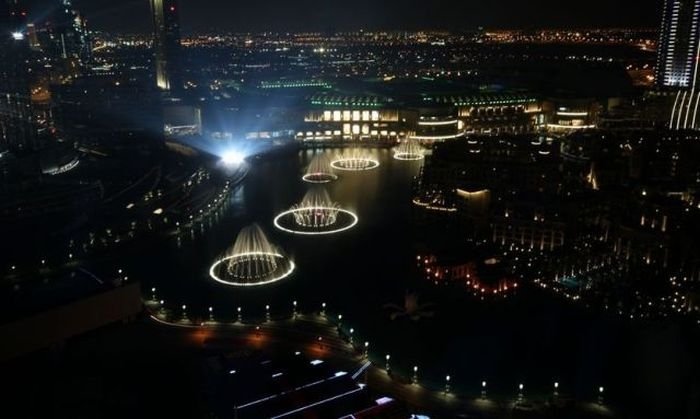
left=117, top=150, right=700, bottom=417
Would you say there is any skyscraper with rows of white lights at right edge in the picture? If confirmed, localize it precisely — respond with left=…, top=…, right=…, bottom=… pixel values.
left=656, top=0, right=700, bottom=129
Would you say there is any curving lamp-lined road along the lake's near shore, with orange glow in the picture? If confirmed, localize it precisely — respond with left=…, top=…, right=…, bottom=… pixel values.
left=150, top=313, right=615, bottom=419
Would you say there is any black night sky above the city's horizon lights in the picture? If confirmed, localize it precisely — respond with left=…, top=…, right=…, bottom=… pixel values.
left=58, top=0, right=662, bottom=32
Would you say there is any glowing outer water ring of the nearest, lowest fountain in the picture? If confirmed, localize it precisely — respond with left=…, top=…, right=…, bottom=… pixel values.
left=209, top=252, right=296, bottom=287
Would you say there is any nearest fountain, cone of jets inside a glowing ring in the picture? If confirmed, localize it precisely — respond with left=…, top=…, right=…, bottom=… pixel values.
left=209, top=224, right=295, bottom=287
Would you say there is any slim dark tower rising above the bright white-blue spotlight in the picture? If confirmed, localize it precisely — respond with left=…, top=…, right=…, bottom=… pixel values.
left=151, top=0, right=182, bottom=93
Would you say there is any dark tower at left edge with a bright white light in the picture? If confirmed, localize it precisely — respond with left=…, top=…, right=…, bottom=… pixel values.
left=0, top=0, right=37, bottom=151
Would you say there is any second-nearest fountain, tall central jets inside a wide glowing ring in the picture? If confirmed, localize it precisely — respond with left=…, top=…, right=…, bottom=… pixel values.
left=275, top=188, right=358, bottom=235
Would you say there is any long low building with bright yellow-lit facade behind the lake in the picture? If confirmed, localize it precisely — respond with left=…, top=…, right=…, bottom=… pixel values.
left=297, top=93, right=544, bottom=143
